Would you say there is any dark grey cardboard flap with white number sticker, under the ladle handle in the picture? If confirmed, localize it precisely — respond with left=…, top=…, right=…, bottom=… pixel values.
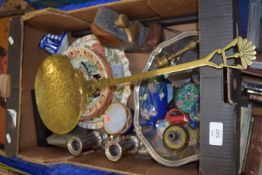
left=199, top=0, right=241, bottom=175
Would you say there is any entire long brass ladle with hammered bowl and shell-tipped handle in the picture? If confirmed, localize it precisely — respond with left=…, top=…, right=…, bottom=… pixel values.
left=35, top=37, right=256, bottom=134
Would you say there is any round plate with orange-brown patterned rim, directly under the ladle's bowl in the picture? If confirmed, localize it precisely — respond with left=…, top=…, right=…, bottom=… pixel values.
left=64, top=48, right=112, bottom=120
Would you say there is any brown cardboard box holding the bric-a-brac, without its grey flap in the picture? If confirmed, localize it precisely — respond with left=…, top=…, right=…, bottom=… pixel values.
left=6, top=0, right=203, bottom=175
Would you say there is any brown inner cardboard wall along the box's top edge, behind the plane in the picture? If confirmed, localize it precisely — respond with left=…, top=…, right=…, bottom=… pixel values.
left=22, top=0, right=198, bottom=33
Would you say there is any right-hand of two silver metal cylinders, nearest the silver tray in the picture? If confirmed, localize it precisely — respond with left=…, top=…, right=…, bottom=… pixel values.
left=105, top=136, right=140, bottom=162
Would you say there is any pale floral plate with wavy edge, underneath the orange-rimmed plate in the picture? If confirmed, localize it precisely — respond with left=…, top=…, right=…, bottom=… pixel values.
left=65, top=35, right=131, bottom=129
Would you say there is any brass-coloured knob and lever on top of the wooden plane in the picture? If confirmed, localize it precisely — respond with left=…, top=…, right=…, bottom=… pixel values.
left=114, top=14, right=139, bottom=43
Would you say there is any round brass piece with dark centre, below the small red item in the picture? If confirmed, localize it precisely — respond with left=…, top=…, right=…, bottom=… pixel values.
left=163, top=125, right=189, bottom=151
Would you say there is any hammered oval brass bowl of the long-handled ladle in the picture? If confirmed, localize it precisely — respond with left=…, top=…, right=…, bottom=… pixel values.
left=35, top=55, right=82, bottom=134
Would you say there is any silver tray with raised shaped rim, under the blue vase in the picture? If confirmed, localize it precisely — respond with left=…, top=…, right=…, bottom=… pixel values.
left=134, top=31, right=199, bottom=167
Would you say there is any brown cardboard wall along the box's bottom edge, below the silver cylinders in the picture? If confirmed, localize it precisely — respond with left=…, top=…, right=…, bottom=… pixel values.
left=18, top=147, right=199, bottom=175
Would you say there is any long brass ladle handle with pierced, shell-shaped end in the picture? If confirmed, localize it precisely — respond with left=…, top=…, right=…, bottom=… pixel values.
left=86, top=37, right=256, bottom=94
